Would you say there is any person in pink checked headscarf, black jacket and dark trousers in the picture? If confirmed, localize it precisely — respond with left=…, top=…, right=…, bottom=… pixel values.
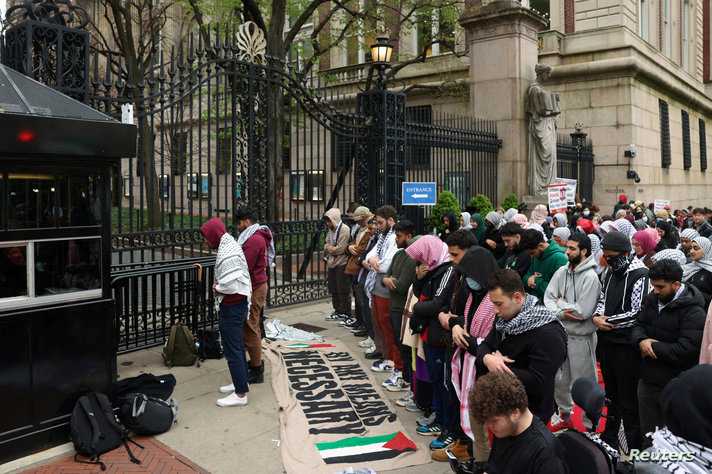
left=405, top=237, right=454, bottom=435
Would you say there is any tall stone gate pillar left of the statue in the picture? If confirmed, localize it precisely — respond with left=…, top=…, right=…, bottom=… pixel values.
left=460, top=0, right=546, bottom=203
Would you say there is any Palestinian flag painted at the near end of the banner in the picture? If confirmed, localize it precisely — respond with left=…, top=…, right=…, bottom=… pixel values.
left=316, top=431, right=418, bottom=464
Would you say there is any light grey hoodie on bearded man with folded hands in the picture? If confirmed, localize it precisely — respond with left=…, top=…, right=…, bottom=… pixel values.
left=544, top=256, right=601, bottom=336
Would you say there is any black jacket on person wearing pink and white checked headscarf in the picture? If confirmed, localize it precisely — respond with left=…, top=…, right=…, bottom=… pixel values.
left=410, top=262, right=455, bottom=344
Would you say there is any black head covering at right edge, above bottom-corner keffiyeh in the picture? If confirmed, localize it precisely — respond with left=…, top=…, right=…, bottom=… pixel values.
left=660, top=364, right=712, bottom=448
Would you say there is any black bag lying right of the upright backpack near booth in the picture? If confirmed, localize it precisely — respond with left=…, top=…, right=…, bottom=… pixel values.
left=119, top=393, right=178, bottom=435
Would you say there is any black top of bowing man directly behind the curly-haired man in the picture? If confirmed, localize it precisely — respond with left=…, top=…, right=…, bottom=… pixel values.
left=476, top=317, right=567, bottom=420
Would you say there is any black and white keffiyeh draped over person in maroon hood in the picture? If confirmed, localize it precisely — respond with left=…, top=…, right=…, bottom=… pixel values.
left=215, top=232, right=252, bottom=318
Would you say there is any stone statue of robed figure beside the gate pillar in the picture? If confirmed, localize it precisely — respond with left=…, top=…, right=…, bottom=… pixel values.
left=524, top=64, right=561, bottom=196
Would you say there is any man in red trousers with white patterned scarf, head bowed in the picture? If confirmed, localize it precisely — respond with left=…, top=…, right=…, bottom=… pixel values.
left=363, top=205, right=398, bottom=372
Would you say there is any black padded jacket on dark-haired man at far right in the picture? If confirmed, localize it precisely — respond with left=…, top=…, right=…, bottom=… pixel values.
left=632, top=285, right=707, bottom=387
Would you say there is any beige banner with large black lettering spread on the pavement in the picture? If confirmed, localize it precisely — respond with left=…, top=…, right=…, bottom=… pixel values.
left=263, top=340, right=430, bottom=474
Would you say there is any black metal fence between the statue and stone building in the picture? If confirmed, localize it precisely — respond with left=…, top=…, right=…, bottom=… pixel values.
left=556, top=134, right=594, bottom=202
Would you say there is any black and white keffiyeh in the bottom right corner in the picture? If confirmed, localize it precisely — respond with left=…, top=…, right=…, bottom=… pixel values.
left=650, top=428, right=712, bottom=474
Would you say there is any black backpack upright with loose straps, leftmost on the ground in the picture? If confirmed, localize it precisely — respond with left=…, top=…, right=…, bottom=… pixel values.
left=69, top=392, right=143, bottom=471
